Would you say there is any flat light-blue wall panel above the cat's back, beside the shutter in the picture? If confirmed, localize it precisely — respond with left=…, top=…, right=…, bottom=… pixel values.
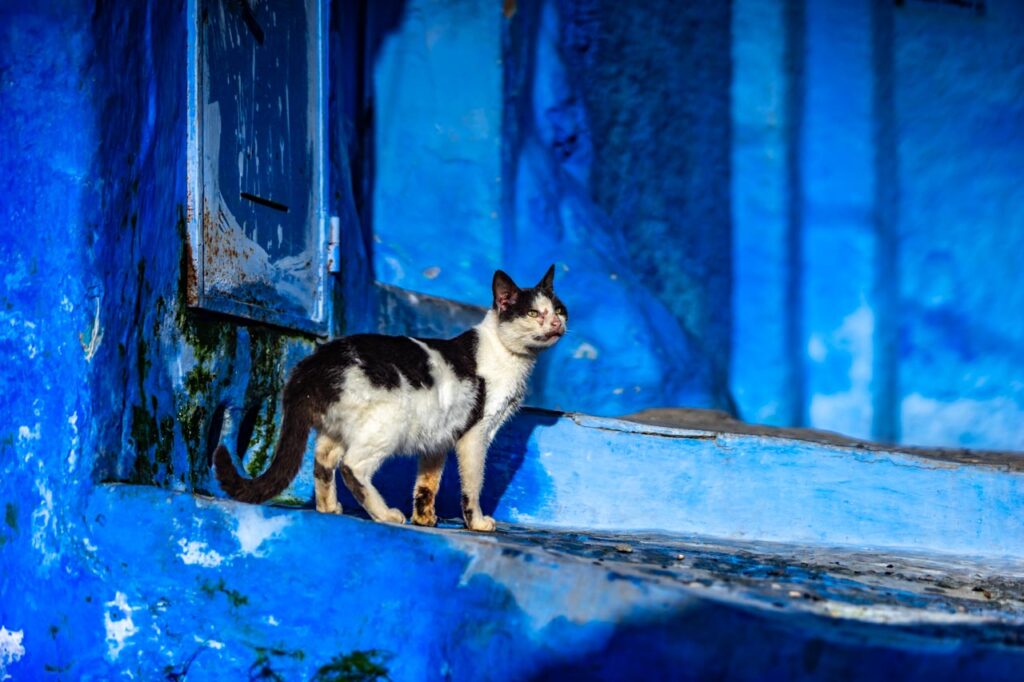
left=368, top=0, right=501, bottom=305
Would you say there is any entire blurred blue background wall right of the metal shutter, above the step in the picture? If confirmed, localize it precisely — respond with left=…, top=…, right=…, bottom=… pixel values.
left=368, top=0, right=1024, bottom=449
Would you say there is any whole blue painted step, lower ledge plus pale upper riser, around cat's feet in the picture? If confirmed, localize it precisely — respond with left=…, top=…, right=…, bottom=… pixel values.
left=3, top=411, right=1024, bottom=682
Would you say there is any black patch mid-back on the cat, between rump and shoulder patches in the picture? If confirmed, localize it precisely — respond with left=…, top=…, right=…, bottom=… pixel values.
left=345, top=334, right=434, bottom=390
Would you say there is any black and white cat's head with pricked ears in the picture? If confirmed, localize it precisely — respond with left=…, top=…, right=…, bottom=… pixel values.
left=490, top=265, right=568, bottom=353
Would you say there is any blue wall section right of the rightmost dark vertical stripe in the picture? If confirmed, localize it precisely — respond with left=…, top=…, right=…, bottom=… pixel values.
left=891, top=0, right=1024, bottom=450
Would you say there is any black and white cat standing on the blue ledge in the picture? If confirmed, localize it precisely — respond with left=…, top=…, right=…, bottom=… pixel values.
left=214, top=265, right=567, bottom=530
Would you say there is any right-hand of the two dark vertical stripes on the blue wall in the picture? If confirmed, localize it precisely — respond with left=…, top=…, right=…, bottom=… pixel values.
left=871, top=0, right=899, bottom=442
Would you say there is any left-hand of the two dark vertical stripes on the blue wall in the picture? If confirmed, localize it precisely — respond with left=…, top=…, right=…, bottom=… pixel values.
left=783, top=0, right=807, bottom=426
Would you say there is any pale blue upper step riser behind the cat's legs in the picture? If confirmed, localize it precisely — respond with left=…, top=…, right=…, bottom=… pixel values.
left=329, top=410, right=1024, bottom=560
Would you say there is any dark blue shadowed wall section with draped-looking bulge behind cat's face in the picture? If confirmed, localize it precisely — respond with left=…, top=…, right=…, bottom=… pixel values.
left=504, top=0, right=733, bottom=415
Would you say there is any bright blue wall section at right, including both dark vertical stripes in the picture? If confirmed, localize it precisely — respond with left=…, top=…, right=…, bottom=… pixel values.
left=729, top=1, right=1024, bottom=450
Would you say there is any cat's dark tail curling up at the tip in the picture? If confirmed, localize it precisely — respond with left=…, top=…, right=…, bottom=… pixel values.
left=213, top=400, right=313, bottom=504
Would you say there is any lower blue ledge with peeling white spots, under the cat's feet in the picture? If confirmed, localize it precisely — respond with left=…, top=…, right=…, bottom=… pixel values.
left=77, top=485, right=1024, bottom=681
